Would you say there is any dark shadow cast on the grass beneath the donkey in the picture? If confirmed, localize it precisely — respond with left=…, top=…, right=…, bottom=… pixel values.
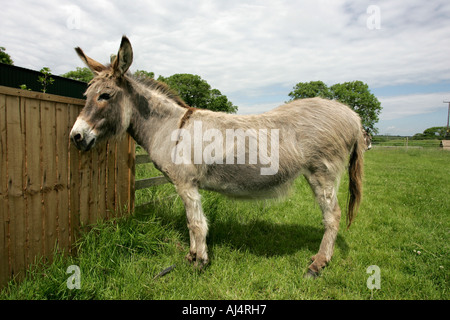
left=136, top=202, right=349, bottom=257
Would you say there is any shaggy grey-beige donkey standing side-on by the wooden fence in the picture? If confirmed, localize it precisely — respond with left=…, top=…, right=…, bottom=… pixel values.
left=70, top=36, right=365, bottom=277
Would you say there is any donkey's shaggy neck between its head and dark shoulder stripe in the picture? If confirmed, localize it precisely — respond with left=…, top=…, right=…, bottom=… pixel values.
left=127, top=79, right=188, bottom=157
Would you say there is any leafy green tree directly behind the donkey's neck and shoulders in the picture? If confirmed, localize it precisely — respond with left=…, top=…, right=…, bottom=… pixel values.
left=158, top=73, right=237, bottom=113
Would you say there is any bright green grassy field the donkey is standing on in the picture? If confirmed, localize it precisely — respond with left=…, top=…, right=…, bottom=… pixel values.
left=0, top=148, right=450, bottom=300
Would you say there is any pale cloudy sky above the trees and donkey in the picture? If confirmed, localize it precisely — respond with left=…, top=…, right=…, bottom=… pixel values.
left=0, top=0, right=450, bottom=135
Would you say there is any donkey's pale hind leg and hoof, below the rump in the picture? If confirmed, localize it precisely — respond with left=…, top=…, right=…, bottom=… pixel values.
left=306, top=173, right=341, bottom=277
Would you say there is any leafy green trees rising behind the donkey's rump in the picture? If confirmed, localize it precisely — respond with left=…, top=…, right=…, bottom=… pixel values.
left=289, top=81, right=381, bottom=133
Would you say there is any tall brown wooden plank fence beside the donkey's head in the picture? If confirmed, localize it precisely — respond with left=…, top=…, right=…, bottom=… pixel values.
left=0, top=86, right=135, bottom=287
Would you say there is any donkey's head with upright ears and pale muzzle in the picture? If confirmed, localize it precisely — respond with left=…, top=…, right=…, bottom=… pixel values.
left=70, top=36, right=133, bottom=151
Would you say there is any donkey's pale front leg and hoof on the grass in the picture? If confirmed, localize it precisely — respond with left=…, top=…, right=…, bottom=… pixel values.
left=177, top=186, right=208, bottom=268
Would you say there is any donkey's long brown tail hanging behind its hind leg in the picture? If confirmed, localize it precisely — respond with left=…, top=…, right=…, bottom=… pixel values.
left=347, top=137, right=364, bottom=229
